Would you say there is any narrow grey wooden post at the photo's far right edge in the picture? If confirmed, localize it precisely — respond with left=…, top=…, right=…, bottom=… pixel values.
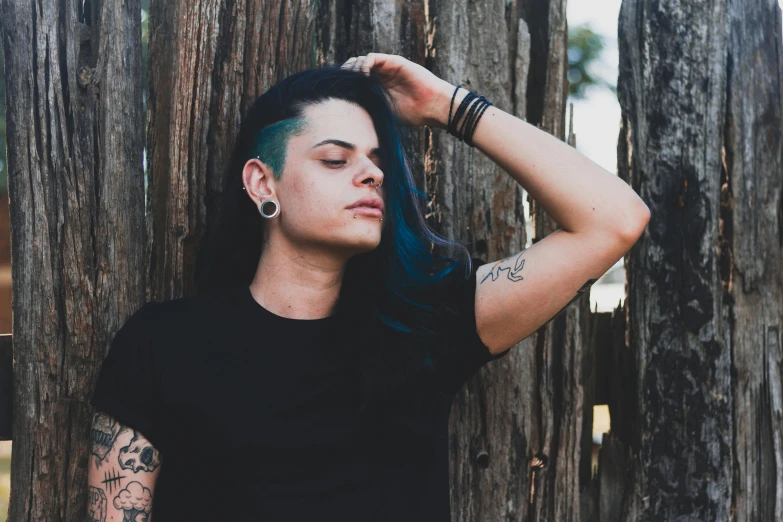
left=720, top=0, right=783, bottom=522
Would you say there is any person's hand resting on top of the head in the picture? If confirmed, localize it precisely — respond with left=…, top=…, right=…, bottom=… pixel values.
left=342, top=53, right=454, bottom=126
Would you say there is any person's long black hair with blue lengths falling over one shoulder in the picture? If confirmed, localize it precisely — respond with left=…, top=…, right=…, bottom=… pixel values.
left=197, top=64, right=471, bottom=402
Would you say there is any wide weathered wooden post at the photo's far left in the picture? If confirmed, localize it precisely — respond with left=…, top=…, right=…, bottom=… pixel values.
left=0, top=0, right=145, bottom=522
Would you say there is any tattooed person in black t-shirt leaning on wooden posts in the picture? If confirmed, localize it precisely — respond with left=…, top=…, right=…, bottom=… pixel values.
left=88, top=53, right=649, bottom=522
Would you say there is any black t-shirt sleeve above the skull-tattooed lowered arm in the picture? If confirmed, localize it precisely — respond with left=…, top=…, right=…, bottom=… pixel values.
left=90, top=303, right=160, bottom=449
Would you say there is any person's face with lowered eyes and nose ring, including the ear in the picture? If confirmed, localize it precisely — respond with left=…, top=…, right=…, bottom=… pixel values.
left=243, top=99, right=386, bottom=259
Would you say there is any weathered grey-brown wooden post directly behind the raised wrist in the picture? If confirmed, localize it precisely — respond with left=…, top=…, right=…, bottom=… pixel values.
left=424, top=0, right=538, bottom=512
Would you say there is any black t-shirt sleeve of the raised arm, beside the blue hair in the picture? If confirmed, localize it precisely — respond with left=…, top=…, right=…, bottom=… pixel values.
left=435, top=257, right=513, bottom=393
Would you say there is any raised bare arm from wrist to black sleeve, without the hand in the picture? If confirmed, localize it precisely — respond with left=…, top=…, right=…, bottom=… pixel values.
left=428, top=81, right=650, bottom=353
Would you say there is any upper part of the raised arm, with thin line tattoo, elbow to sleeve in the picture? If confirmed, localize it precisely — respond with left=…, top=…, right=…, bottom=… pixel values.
left=476, top=229, right=635, bottom=353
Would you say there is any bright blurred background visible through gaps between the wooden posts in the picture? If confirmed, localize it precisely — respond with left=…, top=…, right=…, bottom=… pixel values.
left=0, top=0, right=625, bottom=522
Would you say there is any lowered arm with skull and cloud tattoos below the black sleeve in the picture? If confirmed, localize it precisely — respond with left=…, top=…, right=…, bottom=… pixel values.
left=87, top=411, right=160, bottom=522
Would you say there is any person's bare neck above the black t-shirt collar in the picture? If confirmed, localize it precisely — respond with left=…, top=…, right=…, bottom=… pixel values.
left=250, top=239, right=345, bottom=319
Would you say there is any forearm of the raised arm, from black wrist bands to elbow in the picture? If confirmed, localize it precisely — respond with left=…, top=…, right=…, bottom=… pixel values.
left=430, top=81, right=649, bottom=241
